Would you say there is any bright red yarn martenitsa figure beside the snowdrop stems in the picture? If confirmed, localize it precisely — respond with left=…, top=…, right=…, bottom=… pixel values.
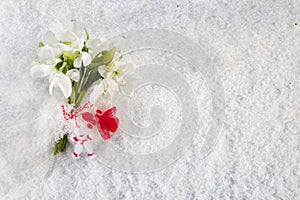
left=81, top=107, right=119, bottom=140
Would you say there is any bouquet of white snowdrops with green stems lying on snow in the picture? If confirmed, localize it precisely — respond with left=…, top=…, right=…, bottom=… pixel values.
left=30, top=20, right=134, bottom=158
